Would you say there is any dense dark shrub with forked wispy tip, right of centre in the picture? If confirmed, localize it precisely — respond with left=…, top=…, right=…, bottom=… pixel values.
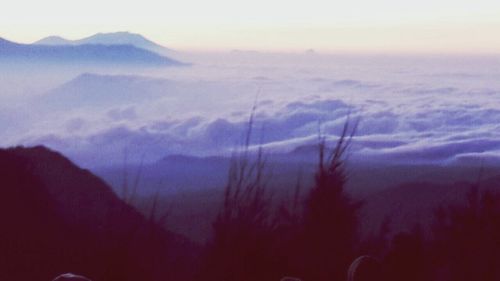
left=302, top=120, right=361, bottom=281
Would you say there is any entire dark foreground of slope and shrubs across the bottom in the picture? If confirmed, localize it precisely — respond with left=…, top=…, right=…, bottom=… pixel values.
left=0, top=143, right=500, bottom=281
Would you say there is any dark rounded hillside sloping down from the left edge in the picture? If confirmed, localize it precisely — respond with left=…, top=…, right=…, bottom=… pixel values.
left=0, top=147, right=195, bottom=281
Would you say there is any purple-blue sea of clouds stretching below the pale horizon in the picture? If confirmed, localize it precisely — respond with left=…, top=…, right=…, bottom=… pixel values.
left=0, top=52, right=500, bottom=167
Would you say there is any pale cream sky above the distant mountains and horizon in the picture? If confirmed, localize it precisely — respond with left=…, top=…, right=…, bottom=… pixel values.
left=0, top=0, right=500, bottom=53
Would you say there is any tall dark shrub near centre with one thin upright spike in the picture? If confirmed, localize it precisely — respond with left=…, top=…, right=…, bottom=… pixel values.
left=198, top=106, right=281, bottom=281
